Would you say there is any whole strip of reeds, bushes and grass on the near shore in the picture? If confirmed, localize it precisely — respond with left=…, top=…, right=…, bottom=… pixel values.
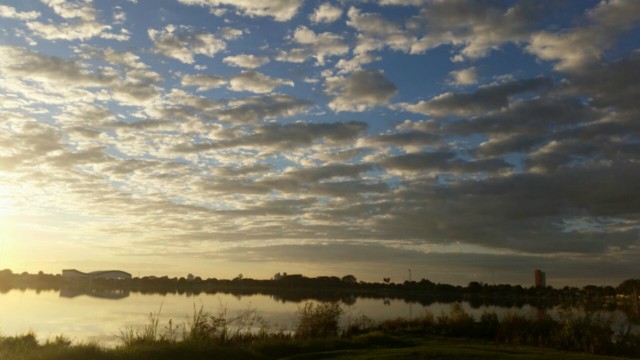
left=0, top=303, right=640, bottom=360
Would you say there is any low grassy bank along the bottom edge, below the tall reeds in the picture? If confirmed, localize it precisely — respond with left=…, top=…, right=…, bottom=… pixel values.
left=0, top=332, right=632, bottom=360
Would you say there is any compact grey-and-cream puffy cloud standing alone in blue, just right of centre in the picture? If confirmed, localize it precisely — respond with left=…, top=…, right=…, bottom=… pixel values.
left=325, top=70, right=397, bottom=112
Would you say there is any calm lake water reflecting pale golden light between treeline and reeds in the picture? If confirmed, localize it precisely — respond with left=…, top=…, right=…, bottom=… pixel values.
left=0, top=289, right=632, bottom=346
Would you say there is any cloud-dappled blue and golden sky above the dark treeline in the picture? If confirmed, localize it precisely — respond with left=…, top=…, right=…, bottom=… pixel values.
left=0, top=0, right=640, bottom=286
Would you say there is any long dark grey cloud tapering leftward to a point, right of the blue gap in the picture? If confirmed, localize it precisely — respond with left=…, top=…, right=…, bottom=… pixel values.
left=401, top=77, right=553, bottom=117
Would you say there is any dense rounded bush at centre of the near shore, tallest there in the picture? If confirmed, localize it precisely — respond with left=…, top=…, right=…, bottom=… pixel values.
left=295, top=302, right=343, bottom=339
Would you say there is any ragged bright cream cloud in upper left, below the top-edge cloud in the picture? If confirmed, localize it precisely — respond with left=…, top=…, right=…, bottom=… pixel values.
left=148, top=25, right=227, bottom=64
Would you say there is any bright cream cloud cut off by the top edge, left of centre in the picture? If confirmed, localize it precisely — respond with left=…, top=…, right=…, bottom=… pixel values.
left=179, top=0, right=302, bottom=21
